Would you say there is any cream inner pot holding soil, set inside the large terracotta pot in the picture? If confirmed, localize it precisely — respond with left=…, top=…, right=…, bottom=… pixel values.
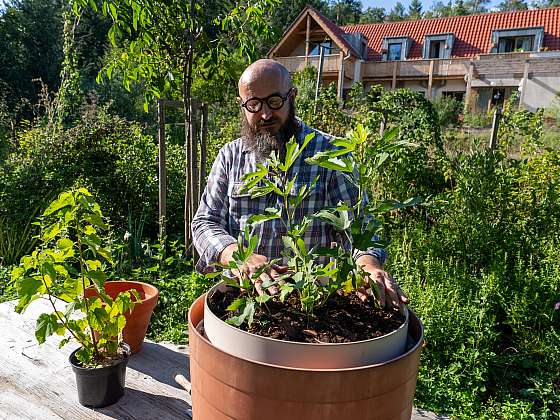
left=204, top=283, right=409, bottom=369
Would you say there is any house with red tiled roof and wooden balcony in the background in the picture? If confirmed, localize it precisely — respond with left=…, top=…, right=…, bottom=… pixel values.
left=268, top=6, right=560, bottom=110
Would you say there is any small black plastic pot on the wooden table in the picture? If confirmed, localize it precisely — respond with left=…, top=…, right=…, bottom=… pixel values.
left=70, top=344, right=130, bottom=408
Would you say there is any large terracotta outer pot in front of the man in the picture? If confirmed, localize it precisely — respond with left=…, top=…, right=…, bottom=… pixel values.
left=188, top=295, right=423, bottom=420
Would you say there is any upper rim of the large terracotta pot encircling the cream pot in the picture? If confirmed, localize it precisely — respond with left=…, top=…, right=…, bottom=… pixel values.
left=192, top=293, right=424, bottom=372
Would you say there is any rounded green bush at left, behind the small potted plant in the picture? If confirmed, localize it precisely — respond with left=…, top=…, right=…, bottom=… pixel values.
left=0, top=101, right=192, bottom=262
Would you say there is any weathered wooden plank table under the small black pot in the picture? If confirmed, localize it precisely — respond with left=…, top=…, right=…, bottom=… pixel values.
left=0, top=300, right=446, bottom=420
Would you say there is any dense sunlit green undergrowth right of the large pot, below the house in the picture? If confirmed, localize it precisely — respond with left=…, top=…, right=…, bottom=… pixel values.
left=386, top=136, right=560, bottom=419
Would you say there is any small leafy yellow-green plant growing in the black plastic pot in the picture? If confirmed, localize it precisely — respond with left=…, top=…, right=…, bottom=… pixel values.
left=12, top=188, right=139, bottom=367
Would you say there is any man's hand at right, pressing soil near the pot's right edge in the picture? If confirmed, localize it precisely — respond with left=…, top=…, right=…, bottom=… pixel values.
left=356, top=255, right=408, bottom=308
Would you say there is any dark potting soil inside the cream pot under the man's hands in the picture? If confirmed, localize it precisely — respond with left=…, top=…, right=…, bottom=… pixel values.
left=208, top=288, right=405, bottom=343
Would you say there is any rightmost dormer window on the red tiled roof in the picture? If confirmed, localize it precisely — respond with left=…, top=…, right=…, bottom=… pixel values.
left=490, top=27, right=544, bottom=53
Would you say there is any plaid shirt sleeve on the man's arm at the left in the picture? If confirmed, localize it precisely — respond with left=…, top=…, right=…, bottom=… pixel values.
left=191, top=147, right=237, bottom=273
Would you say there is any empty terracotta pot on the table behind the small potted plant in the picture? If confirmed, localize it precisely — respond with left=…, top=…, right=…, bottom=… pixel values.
left=86, top=280, right=159, bottom=353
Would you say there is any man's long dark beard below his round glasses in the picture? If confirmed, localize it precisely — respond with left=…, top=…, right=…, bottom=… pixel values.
left=241, top=101, right=299, bottom=162
